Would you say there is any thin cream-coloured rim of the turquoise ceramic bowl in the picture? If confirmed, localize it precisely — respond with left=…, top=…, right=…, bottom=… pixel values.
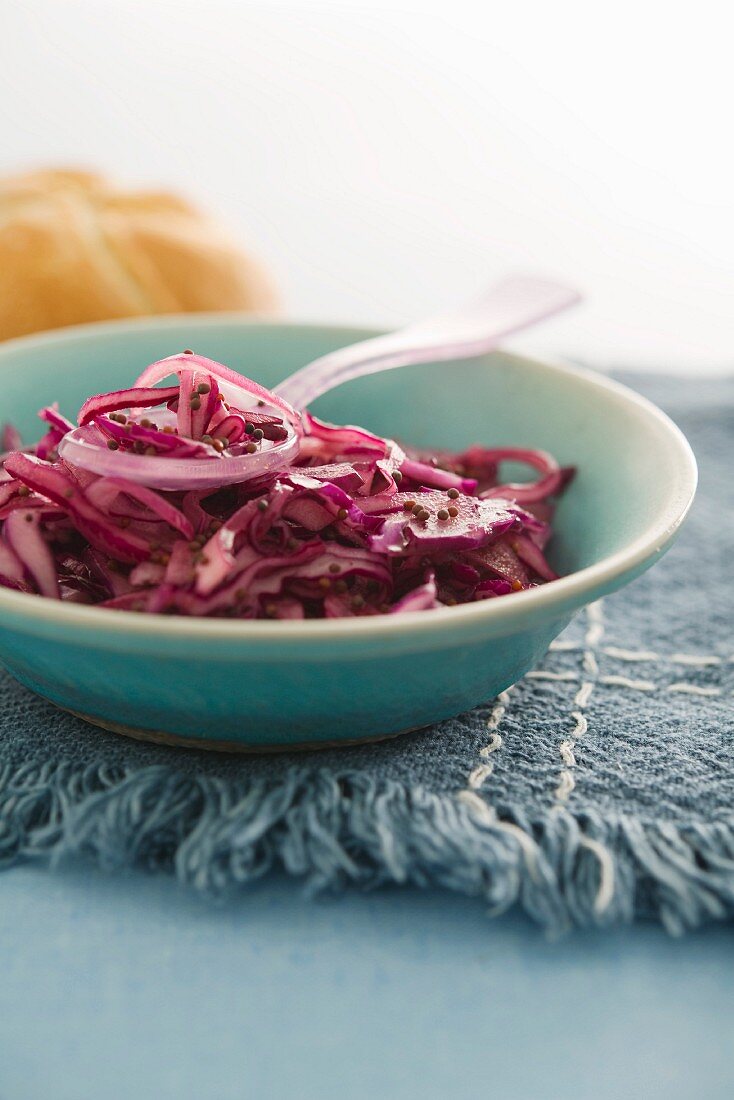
left=0, top=312, right=698, bottom=642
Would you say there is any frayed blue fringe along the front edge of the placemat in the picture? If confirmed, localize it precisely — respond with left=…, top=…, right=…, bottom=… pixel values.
left=0, top=763, right=734, bottom=935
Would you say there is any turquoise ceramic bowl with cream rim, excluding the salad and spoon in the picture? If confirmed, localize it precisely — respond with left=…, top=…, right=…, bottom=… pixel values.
left=0, top=315, right=697, bottom=751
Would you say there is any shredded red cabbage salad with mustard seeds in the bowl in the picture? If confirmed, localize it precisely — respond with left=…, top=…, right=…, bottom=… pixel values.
left=0, top=351, right=572, bottom=619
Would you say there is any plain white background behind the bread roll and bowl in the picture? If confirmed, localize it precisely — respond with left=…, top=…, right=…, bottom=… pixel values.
left=0, top=0, right=734, bottom=371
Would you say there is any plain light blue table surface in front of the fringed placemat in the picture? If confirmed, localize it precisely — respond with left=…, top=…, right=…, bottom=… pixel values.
left=0, top=866, right=734, bottom=1100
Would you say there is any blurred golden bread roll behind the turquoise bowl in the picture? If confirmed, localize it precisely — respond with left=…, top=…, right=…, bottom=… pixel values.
left=0, top=171, right=275, bottom=340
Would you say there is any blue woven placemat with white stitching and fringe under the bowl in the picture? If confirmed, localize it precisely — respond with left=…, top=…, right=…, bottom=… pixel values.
left=0, top=377, right=734, bottom=932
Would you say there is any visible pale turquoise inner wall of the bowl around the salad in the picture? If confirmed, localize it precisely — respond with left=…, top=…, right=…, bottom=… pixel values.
left=0, top=317, right=686, bottom=573
